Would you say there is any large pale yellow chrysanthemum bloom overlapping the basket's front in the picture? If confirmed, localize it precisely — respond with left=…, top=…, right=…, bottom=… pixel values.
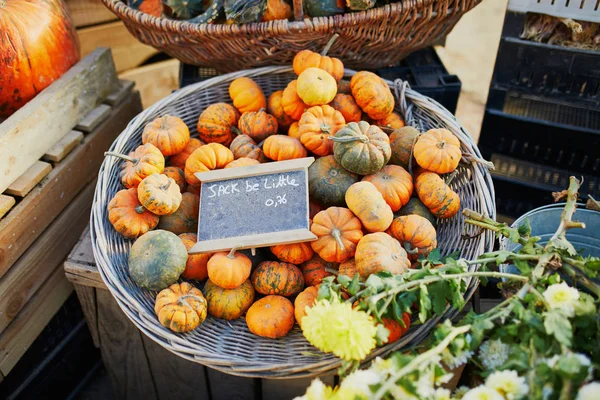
left=302, top=300, right=377, bottom=361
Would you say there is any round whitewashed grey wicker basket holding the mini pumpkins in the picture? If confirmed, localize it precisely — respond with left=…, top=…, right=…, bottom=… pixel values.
left=91, top=67, right=495, bottom=378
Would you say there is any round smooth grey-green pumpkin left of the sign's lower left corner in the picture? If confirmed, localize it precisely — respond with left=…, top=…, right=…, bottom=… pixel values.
left=129, top=230, right=188, bottom=290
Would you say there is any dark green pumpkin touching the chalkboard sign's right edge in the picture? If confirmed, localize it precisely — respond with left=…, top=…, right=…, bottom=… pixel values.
left=308, top=156, right=360, bottom=208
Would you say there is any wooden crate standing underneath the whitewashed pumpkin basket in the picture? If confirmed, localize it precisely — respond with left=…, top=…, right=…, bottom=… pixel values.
left=64, top=228, right=334, bottom=400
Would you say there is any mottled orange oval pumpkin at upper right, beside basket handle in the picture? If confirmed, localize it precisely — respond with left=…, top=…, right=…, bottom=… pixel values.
left=350, top=71, right=395, bottom=120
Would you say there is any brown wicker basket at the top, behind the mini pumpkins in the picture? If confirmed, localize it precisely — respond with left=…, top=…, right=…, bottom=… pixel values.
left=102, top=0, right=481, bottom=72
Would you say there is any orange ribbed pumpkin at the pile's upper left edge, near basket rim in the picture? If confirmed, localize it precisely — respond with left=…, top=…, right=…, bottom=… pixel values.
left=142, top=115, right=190, bottom=156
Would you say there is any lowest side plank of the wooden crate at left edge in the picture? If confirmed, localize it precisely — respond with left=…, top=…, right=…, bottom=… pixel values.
left=0, top=266, right=73, bottom=376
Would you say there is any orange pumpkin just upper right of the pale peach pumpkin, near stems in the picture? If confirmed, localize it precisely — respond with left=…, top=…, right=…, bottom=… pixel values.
left=388, top=214, right=437, bottom=261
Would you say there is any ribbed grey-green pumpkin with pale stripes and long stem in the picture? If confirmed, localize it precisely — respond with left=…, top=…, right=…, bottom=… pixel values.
left=332, top=121, right=392, bottom=175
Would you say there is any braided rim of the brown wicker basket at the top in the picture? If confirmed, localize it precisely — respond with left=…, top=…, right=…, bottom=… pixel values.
left=102, top=0, right=481, bottom=36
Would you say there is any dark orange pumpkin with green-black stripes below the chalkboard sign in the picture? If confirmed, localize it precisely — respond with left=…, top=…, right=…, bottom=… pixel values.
left=250, top=261, right=304, bottom=296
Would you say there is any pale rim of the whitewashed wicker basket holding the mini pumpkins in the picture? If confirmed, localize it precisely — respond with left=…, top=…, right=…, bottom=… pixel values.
left=90, top=66, right=496, bottom=379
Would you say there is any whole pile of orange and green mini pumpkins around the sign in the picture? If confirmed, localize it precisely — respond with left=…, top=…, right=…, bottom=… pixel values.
left=108, top=43, right=462, bottom=340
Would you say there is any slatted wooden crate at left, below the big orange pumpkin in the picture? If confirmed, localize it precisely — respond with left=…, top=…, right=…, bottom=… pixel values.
left=0, top=55, right=141, bottom=381
